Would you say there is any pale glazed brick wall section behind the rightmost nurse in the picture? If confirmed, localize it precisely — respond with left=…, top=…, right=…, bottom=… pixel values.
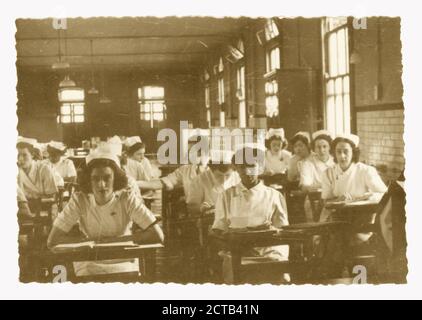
left=356, top=109, right=405, bottom=180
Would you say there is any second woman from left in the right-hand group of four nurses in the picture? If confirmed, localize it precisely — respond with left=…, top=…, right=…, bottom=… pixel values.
left=287, top=131, right=311, bottom=185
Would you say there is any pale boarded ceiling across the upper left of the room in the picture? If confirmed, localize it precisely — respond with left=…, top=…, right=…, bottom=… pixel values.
left=16, top=17, right=250, bottom=70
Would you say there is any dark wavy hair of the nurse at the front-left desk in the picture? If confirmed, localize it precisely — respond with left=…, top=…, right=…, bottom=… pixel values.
left=78, top=159, right=128, bottom=193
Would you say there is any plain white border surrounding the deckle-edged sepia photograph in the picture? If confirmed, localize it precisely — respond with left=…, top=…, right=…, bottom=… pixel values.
left=0, top=0, right=422, bottom=300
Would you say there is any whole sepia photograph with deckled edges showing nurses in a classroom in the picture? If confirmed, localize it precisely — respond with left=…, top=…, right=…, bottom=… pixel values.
left=12, top=10, right=408, bottom=286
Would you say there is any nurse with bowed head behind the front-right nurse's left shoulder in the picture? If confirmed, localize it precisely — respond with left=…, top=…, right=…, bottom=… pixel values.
left=186, top=150, right=240, bottom=214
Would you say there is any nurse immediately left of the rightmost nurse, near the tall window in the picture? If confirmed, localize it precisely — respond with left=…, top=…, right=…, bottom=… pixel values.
left=299, top=130, right=334, bottom=192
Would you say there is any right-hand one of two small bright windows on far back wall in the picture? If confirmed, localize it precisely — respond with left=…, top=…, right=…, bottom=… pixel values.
left=138, top=86, right=166, bottom=128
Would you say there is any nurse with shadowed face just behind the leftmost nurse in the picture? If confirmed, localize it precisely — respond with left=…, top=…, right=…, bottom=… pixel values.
left=46, top=141, right=76, bottom=183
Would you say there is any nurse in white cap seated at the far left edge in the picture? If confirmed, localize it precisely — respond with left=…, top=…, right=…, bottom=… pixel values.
left=16, top=137, right=58, bottom=201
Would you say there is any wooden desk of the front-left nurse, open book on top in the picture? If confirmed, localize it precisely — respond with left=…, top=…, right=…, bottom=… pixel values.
left=33, top=243, right=164, bottom=283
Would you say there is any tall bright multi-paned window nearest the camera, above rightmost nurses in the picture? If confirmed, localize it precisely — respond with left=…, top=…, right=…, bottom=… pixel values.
left=324, top=17, right=350, bottom=134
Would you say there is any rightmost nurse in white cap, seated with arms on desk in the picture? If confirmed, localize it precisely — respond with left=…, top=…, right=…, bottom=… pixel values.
left=320, top=134, right=387, bottom=221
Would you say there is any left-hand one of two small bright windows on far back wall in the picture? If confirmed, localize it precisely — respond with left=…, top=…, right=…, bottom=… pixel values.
left=57, top=88, right=85, bottom=123
